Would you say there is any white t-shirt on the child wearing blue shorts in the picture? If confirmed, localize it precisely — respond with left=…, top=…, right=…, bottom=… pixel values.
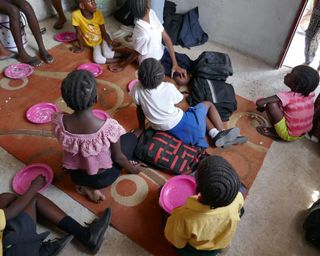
left=130, top=82, right=183, bottom=131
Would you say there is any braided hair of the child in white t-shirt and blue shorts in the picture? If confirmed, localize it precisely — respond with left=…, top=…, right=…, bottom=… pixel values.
left=138, top=58, right=165, bottom=89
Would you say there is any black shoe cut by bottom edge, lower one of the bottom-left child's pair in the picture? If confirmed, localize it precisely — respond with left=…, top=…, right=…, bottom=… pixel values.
left=40, top=235, right=73, bottom=256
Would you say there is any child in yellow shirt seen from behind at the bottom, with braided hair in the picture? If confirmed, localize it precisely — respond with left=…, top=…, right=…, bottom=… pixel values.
left=165, top=156, right=244, bottom=256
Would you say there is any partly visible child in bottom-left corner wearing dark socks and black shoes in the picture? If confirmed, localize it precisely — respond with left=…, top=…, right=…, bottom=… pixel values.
left=0, top=176, right=111, bottom=256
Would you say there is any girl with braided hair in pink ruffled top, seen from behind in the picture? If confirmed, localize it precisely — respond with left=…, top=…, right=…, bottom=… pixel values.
left=53, top=70, right=140, bottom=203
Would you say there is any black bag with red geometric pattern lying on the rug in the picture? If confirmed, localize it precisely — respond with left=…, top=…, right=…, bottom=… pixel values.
left=135, top=129, right=205, bottom=175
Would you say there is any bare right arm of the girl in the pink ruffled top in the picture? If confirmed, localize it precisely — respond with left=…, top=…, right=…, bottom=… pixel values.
left=110, top=140, right=141, bottom=174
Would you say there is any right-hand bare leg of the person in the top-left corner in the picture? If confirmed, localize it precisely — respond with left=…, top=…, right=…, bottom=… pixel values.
left=11, top=0, right=53, bottom=63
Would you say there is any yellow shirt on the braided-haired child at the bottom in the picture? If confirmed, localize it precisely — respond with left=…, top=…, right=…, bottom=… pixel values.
left=165, top=192, right=244, bottom=250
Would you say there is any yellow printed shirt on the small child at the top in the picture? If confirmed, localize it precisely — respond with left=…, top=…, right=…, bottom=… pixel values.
left=71, top=10, right=104, bottom=47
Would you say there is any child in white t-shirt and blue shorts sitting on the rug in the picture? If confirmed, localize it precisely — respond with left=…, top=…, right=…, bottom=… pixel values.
left=130, top=58, right=245, bottom=148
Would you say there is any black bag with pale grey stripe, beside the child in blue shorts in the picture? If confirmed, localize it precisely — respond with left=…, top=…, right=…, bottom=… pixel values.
left=187, top=77, right=237, bottom=121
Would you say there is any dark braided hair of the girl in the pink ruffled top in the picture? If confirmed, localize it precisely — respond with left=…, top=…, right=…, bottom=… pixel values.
left=61, top=70, right=97, bottom=111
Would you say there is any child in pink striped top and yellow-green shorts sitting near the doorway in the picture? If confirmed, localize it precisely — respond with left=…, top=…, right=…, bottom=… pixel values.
left=256, top=65, right=319, bottom=141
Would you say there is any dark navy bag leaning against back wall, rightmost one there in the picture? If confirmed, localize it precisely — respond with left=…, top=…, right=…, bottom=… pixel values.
left=178, top=7, right=208, bottom=47
